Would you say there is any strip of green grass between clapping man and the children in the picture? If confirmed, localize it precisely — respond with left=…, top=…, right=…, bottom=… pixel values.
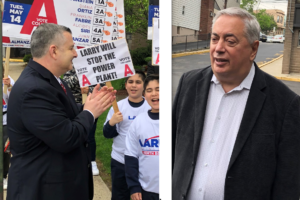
left=95, top=109, right=113, bottom=174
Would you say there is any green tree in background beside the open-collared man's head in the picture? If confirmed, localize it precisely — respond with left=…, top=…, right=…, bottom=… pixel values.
left=255, top=9, right=277, bottom=33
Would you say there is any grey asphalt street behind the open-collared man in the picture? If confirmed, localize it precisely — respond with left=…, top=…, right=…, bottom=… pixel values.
left=172, top=42, right=284, bottom=98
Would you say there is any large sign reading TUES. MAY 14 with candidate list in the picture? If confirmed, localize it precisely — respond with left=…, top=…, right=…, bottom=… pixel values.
left=3, top=0, right=116, bottom=46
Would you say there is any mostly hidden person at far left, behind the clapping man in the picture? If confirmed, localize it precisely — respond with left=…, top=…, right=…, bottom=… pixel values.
left=2, top=73, right=15, bottom=190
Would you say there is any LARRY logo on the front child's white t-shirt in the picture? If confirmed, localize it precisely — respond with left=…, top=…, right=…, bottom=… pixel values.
left=139, top=135, right=159, bottom=156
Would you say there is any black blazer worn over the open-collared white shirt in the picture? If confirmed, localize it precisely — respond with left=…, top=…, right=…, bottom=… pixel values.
left=172, top=64, right=300, bottom=200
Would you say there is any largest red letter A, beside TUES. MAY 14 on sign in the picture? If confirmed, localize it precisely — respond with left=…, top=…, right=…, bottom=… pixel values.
left=20, top=0, right=57, bottom=35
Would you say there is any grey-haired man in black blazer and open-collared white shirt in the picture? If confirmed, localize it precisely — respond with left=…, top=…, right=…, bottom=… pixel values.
left=172, top=8, right=300, bottom=200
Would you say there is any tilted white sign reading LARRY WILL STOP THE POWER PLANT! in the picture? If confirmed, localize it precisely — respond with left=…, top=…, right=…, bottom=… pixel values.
left=73, top=39, right=135, bottom=87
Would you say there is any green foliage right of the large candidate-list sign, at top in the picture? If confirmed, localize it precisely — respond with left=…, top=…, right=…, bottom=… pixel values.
left=124, top=0, right=149, bottom=36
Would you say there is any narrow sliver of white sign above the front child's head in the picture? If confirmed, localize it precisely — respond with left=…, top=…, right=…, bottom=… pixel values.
left=152, top=18, right=159, bottom=66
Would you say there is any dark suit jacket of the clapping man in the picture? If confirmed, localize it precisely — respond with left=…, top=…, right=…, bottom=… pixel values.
left=7, top=60, right=94, bottom=200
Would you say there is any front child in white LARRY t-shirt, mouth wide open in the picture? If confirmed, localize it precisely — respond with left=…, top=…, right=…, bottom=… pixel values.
left=125, top=75, right=160, bottom=200
